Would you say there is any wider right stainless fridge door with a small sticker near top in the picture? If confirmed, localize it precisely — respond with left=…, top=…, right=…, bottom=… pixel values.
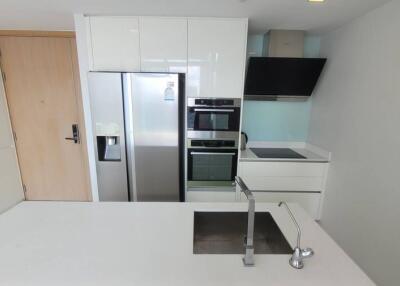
left=123, top=73, right=179, bottom=201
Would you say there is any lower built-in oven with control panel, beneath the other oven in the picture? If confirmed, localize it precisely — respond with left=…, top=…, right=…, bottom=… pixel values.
left=187, top=138, right=238, bottom=188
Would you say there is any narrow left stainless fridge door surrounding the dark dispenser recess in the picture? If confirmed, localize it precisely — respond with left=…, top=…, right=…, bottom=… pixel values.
left=88, top=72, right=128, bottom=201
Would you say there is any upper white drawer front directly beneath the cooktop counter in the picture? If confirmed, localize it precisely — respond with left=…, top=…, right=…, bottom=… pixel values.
left=239, top=162, right=326, bottom=177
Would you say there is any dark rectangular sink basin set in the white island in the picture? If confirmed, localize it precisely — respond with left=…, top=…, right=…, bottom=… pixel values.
left=193, top=212, right=293, bottom=254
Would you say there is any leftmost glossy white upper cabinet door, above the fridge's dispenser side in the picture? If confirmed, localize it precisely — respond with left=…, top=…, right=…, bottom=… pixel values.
left=89, top=16, right=140, bottom=71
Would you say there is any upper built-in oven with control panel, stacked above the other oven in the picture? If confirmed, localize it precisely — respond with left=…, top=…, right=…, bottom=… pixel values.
left=187, top=98, right=241, bottom=135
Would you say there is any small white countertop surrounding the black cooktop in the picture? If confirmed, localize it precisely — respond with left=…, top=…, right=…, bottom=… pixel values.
left=239, top=142, right=330, bottom=163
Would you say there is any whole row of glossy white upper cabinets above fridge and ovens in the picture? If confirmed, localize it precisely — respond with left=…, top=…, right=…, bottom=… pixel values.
left=87, top=16, right=247, bottom=98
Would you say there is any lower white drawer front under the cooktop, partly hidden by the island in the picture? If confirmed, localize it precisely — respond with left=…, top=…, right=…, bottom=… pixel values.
left=240, top=192, right=321, bottom=219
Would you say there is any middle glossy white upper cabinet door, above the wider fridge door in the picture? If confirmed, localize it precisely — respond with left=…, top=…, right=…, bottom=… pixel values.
left=140, top=17, right=187, bottom=73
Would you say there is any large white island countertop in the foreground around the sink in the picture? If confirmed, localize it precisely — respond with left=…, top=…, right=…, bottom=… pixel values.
left=0, top=202, right=375, bottom=286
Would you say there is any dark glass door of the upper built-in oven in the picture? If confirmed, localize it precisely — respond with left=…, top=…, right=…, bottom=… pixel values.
left=188, top=107, right=240, bottom=131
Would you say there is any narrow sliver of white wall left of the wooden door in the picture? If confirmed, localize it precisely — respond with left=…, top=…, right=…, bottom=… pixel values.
left=0, top=70, right=24, bottom=213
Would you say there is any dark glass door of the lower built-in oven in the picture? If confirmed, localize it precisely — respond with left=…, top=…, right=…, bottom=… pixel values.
left=188, top=148, right=238, bottom=185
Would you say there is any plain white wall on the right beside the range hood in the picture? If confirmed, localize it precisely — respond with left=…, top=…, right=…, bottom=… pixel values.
left=309, top=1, right=400, bottom=286
